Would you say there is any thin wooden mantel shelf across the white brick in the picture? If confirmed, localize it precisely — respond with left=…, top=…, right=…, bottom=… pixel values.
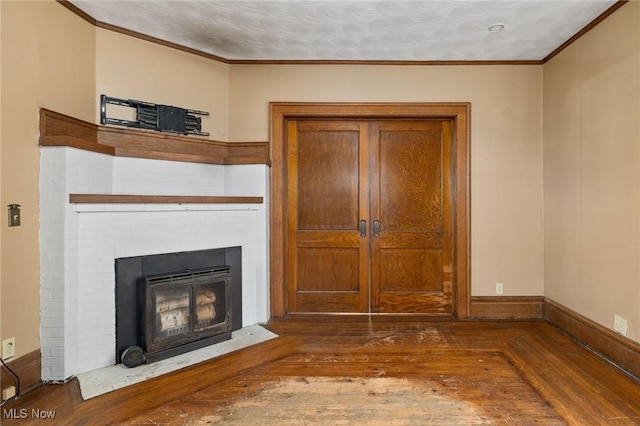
left=69, top=194, right=264, bottom=204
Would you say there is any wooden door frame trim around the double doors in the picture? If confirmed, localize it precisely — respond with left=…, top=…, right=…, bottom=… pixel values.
left=269, top=102, right=471, bottom=319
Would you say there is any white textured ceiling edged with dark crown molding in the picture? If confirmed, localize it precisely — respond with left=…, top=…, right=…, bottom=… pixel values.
left=71, top=0, right=616, bottom=61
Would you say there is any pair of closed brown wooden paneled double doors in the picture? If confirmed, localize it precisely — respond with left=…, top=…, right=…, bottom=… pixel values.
left=285, top=119, right=455, bottom=314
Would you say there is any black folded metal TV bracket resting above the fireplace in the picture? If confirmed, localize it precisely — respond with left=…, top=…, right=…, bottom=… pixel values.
left=100, top=95, right=209, bottom=136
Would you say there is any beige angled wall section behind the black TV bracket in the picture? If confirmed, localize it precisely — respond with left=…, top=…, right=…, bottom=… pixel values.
left=96, top=29, right=229, bottom=141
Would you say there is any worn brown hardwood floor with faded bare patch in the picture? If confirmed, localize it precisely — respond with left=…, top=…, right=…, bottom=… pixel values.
left=2, top=322, right=640, bottom=425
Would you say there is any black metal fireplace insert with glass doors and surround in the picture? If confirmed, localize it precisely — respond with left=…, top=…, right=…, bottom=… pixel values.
left=116, top=247, right=242, bottom=367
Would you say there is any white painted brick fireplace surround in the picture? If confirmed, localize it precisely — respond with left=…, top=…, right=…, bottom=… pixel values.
left=40, top=147, right=269, bottom=381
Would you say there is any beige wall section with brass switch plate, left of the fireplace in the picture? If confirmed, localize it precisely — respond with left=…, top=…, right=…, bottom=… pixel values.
left=0, top=1, right=94, bottom=357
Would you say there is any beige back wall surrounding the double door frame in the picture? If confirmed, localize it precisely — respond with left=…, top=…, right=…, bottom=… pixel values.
left=229, top=65, right=543, bottom=296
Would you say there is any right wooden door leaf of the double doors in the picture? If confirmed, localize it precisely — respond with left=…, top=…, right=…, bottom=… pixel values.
left=370, top=120, right=453, bottom=313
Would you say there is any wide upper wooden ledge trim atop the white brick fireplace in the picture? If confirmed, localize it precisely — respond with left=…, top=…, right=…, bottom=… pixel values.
left=39, top=108, right=270, bottom=165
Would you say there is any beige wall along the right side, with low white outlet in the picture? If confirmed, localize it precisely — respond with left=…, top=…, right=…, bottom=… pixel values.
left=543, top=2, right=640, bottom=341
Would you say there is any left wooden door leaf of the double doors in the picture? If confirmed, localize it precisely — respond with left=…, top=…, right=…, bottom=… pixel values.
left=287, top=121, right=369, bottom=312
